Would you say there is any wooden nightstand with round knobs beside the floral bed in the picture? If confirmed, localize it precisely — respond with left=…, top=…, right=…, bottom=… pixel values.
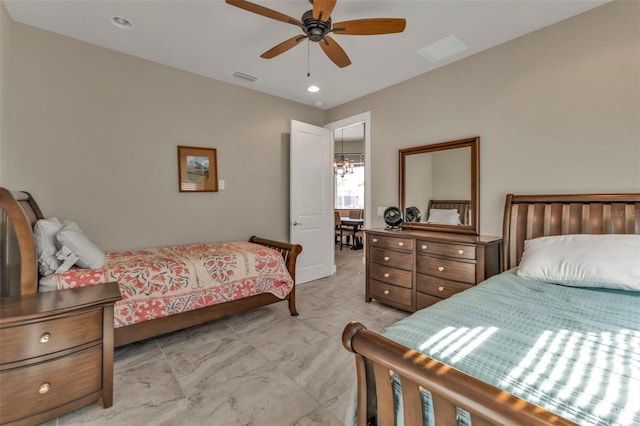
left=0, top=283, right=120, bottom=424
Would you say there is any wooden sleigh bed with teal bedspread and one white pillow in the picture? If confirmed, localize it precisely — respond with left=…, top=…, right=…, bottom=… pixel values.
left=343, top=194, right=640, bottom=426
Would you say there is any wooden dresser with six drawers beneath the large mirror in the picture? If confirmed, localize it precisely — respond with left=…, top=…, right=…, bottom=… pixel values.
left=365, top=229, right=502, bottom=311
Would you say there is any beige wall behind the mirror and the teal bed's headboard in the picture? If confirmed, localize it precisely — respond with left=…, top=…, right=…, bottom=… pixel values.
left=327, top=1, right=640, bottom=235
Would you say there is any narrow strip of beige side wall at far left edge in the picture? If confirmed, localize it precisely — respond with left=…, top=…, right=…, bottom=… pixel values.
left=0, top=2, right=13, bottom=185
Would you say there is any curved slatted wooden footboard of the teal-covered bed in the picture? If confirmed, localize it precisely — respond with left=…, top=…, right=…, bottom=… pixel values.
left=342, top=322, right=575, bottom=426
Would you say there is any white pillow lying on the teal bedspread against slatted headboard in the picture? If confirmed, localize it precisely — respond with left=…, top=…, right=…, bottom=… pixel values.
left=518, top=234, right=640, bottom=291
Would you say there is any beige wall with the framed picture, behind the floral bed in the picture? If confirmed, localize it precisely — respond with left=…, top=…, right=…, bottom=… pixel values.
left=9, top=23, right=325, bottom=250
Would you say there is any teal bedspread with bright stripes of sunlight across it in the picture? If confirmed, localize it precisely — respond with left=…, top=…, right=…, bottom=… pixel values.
left=383, top=270, right=640, bottom=425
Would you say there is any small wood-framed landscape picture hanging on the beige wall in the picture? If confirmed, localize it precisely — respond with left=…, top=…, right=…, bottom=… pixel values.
left=178, top=145, right=218, bottom=192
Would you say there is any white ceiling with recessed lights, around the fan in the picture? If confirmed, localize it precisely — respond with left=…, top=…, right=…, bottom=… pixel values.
left=4, top=0, right=609, bottom=109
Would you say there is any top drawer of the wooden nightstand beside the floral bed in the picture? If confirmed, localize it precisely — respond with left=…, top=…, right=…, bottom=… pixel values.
left=0, top=309, right=102, bottom=364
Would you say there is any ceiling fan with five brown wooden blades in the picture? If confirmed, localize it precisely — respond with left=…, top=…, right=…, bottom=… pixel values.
left=226, top=0, right=406, bottom=68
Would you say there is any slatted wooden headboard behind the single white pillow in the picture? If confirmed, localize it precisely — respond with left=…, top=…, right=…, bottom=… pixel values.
left=502, top=194, right=640, bottom=269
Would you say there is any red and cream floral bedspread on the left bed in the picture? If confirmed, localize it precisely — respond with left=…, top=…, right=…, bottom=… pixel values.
left=56, top=242, right=294, bottom=328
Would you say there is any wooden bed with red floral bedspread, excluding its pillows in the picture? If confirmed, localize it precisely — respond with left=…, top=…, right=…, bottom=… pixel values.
left=0, top=188, right=302, bottom=346
